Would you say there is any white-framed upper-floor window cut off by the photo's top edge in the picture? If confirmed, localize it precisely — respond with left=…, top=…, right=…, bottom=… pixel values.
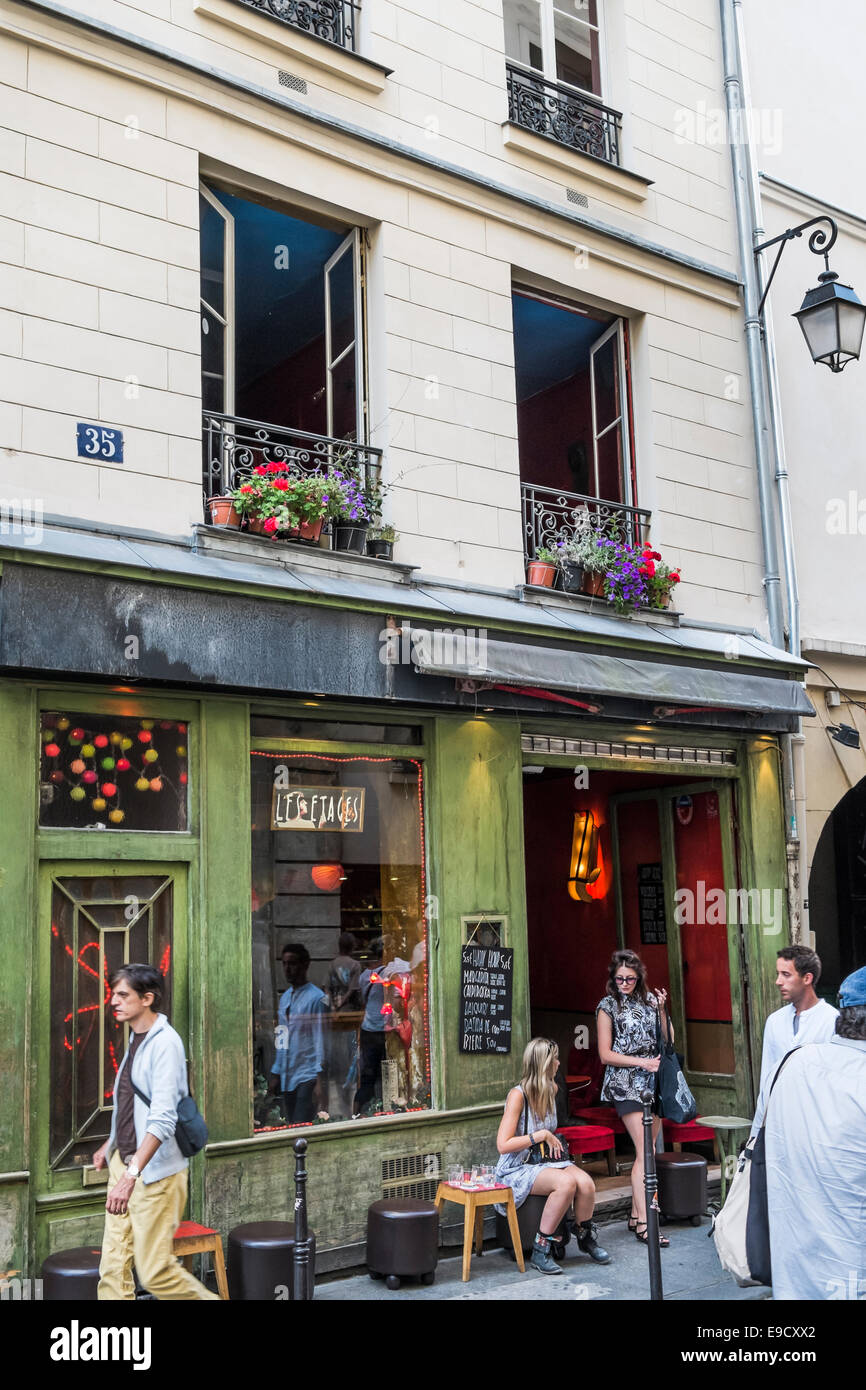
left=503, top=0, right=602, bottom=97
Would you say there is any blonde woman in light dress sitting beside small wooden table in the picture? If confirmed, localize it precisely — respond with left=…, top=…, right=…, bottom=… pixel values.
left=496, top=1038, right=610, bottom=1275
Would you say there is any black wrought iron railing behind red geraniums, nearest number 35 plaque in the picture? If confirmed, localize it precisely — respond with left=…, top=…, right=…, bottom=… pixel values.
left=203, top=410, right=382, bottom=500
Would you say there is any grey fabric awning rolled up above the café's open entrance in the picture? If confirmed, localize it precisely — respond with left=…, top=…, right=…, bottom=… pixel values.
left=414, top=634, right=815, bottom=714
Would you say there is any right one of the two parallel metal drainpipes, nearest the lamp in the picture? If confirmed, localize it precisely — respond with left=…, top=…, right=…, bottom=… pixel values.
left=734, top=0, right=809, bottom=942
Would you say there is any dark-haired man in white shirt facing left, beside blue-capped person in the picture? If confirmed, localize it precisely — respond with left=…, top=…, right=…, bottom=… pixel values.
left=751, top=947, right=838, bottom=1138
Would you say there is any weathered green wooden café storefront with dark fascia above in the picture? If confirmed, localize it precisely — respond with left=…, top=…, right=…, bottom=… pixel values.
left=0, top=530, right=798, bottom=1275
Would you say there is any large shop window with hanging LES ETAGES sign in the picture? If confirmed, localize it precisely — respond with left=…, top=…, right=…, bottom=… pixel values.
left=250, top=752, right=431, bottom=1131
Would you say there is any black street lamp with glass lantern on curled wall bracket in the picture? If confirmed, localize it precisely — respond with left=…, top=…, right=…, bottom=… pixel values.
left=755, top=217, right=866, bottom=371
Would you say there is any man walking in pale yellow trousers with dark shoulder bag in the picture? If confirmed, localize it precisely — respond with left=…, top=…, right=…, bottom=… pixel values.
left=93, top=965, right=217, bottom=1300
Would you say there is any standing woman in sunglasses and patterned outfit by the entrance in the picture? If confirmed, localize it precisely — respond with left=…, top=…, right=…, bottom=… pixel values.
left=595, top=951, right=674, bottom=1245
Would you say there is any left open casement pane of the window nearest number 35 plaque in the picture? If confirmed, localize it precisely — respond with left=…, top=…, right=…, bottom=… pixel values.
left=199, top=186, right=235, bottom=416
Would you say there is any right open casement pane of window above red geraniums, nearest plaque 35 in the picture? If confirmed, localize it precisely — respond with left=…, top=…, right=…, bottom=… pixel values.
left=324, top=228, right=366, bottom=442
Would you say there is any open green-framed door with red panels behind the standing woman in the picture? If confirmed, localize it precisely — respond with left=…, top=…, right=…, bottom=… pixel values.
left=610, top=781, right=752, bottom=1115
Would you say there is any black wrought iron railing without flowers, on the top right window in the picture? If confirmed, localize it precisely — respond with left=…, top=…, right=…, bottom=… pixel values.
left=506, top=63, right=623, bottom=164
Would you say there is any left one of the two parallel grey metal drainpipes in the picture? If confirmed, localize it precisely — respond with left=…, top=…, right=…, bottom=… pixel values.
left=719, top=0, right=802, bottom=941
